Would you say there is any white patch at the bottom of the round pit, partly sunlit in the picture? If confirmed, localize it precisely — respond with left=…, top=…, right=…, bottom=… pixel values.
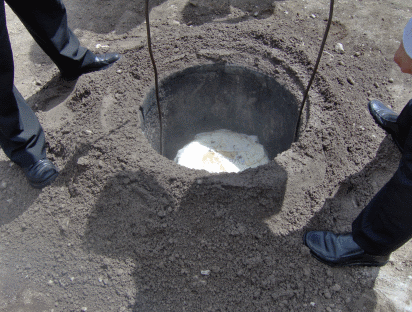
left=174, top=129, right=269, bottom=173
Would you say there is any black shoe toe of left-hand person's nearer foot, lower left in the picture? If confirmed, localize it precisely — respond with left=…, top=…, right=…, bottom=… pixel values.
left=23, top=158, right=59, bottom=189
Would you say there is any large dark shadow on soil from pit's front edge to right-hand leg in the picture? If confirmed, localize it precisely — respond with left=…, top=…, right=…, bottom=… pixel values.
left=80, top=139, right=397, bottom=311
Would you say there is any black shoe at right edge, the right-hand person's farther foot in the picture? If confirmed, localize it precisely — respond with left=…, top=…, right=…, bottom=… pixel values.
left=368, top=100, right=404, bottom=153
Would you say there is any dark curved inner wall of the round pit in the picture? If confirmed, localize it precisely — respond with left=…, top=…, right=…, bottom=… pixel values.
left=141, top=64, right=298, bottom=160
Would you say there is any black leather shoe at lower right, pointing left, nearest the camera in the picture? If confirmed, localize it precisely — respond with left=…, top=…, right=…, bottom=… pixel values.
left=303, top=231, right=389, bottom=266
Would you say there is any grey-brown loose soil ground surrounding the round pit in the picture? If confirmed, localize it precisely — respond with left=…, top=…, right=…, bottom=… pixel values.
left=0, top=0, right=412, bottom=312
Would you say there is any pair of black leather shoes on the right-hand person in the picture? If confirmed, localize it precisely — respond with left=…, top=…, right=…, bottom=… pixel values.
left=303, top=100, right=405, bottom=266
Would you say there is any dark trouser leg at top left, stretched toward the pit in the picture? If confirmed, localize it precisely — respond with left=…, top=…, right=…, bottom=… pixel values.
left=6, top=0, right=95, bottom=72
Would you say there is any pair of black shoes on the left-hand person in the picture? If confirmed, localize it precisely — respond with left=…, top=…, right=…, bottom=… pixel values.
left=23, top=53, right=120, bottom=189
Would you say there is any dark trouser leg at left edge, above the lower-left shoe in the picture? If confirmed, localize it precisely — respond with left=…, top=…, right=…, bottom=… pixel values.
left=0, top=1, right=46, bottom=167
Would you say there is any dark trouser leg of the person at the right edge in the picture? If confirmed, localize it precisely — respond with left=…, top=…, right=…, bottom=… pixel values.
left=352, top=127, right=412, bottom=255
